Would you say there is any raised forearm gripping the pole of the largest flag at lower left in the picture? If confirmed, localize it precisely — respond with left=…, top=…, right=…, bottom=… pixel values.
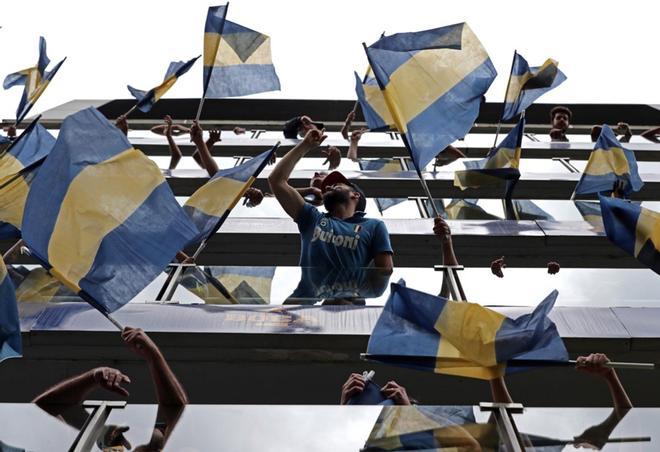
left=121, top=327, right=188, bottom=406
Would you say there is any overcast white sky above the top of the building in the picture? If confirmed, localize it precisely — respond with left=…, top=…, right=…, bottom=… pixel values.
left=0, top=0, right=660, bottom=118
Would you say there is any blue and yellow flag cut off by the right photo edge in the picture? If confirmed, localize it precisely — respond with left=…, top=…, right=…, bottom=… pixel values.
left=599, top=196, right=660, bottom=274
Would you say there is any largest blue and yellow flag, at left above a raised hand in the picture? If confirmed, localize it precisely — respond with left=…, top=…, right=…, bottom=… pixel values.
left=23, top=108, right=198, bottom=313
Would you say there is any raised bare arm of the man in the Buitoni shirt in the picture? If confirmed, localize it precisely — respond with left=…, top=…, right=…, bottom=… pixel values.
left=268, top=129, right=326, bottom=220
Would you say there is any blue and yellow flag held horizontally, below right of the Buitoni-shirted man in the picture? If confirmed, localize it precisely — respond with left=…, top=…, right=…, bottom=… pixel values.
left=367, top=284, right=568, bottom=380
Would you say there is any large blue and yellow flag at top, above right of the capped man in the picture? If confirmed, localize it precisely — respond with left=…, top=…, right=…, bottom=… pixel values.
left=365, top=23, right=497, bottom=171
